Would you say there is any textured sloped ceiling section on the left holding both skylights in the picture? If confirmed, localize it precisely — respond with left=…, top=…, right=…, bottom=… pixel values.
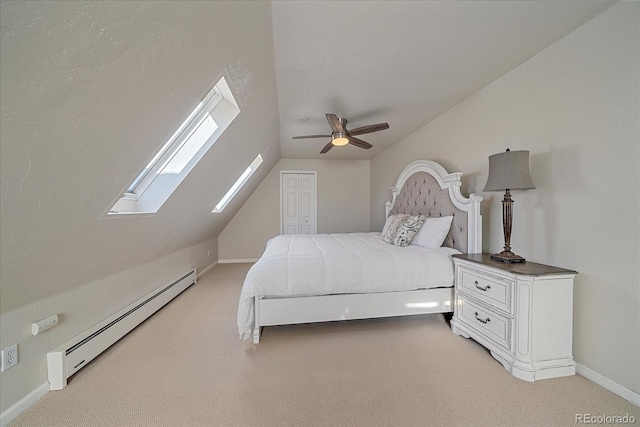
left=0, top=1, right=280, bottom=312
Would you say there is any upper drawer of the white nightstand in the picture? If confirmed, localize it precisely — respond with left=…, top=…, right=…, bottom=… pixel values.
left=458, top=268, right=513, bottom=313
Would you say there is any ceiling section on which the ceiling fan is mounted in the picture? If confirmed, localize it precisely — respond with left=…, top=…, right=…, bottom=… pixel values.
left=272, top=0, right=615, bottom=159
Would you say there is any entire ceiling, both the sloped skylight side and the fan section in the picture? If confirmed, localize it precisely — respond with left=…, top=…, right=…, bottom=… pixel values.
left=0, top=0, right=611, bottom=313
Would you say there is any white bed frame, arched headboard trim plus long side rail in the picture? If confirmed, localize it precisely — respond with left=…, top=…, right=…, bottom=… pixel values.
left=253, top=160, right=482, bottom=344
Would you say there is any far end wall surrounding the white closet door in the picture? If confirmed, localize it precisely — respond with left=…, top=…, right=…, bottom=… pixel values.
left=218, top=159, right=370, bottom=261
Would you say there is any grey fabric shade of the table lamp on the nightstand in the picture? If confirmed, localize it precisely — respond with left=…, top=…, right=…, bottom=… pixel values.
left=484, top=149, right=536, bottom=191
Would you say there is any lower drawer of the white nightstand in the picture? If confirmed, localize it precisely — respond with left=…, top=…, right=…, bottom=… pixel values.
left=458, top=295, right=512, bottom=350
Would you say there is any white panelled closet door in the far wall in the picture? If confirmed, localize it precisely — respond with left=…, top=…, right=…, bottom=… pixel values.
left=280, top=172, right=317, bottom=234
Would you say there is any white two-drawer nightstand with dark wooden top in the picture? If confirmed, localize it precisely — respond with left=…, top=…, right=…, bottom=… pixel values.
left=451, top=254, right=577, bottom=381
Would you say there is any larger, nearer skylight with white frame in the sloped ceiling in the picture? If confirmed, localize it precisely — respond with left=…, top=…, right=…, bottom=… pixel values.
left=108, top=78, right=240, bottom=215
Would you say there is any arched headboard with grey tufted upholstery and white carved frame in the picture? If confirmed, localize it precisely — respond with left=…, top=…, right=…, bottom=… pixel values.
left=386, top=160, right=482, bottom=253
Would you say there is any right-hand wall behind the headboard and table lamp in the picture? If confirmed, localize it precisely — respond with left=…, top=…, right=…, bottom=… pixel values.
left=371, top=2, right=640, bottom=393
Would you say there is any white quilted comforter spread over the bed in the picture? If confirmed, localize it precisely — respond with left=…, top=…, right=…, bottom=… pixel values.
left=238, top=233, right=460, bottom=339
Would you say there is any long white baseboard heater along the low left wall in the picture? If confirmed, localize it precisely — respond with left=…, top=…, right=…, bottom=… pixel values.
left=47, top=269, right=196, bottom=390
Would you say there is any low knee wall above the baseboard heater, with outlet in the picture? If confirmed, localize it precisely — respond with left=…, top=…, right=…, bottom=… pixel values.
left=0, top=238, right=218, bottom=412
